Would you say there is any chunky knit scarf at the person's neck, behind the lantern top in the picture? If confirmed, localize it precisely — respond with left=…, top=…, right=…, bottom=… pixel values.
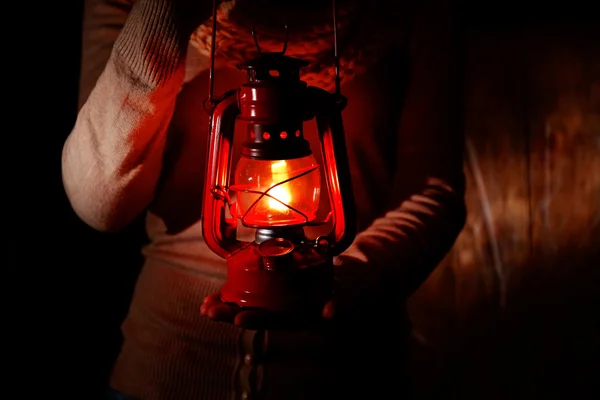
left=191, top=0, right=406, bottom=90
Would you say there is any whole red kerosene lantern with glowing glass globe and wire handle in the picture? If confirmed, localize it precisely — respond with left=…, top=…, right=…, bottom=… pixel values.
left=202, top=3, right=355, bottom=314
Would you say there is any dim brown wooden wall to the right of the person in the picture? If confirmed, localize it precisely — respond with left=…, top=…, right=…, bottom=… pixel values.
left=410, top=19, right=600, bottom=399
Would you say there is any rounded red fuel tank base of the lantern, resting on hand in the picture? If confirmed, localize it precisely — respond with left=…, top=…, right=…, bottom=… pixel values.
left=221, top=243, right=334, bottom=315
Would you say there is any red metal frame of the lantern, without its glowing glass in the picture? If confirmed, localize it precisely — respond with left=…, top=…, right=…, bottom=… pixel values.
left=202, top=0, right=356, bottom=311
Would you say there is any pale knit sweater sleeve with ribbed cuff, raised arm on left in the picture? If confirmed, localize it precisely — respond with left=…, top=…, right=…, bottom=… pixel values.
left=62, top=0, right=211, bottom=231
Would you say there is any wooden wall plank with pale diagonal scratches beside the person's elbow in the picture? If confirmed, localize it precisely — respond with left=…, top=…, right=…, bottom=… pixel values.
left=409, top=29, right=529, bottom=397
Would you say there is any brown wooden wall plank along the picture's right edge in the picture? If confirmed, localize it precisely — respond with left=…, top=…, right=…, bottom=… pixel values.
left=503, top=24, right=600, bottom=398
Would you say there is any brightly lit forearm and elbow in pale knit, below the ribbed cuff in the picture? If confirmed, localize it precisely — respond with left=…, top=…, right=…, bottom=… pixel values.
left=62, top=61, right=182, bottom=231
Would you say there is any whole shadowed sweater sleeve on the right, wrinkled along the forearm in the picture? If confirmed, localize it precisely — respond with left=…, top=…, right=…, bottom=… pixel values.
left=336, top=0, right=466, bottom=297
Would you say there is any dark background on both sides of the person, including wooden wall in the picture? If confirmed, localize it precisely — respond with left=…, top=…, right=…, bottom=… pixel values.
left=9, top=0, right=600, bottom=399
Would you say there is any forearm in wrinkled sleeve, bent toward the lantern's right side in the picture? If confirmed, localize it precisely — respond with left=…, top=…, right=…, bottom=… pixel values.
left=337, top=178, right=466, bottom=297
